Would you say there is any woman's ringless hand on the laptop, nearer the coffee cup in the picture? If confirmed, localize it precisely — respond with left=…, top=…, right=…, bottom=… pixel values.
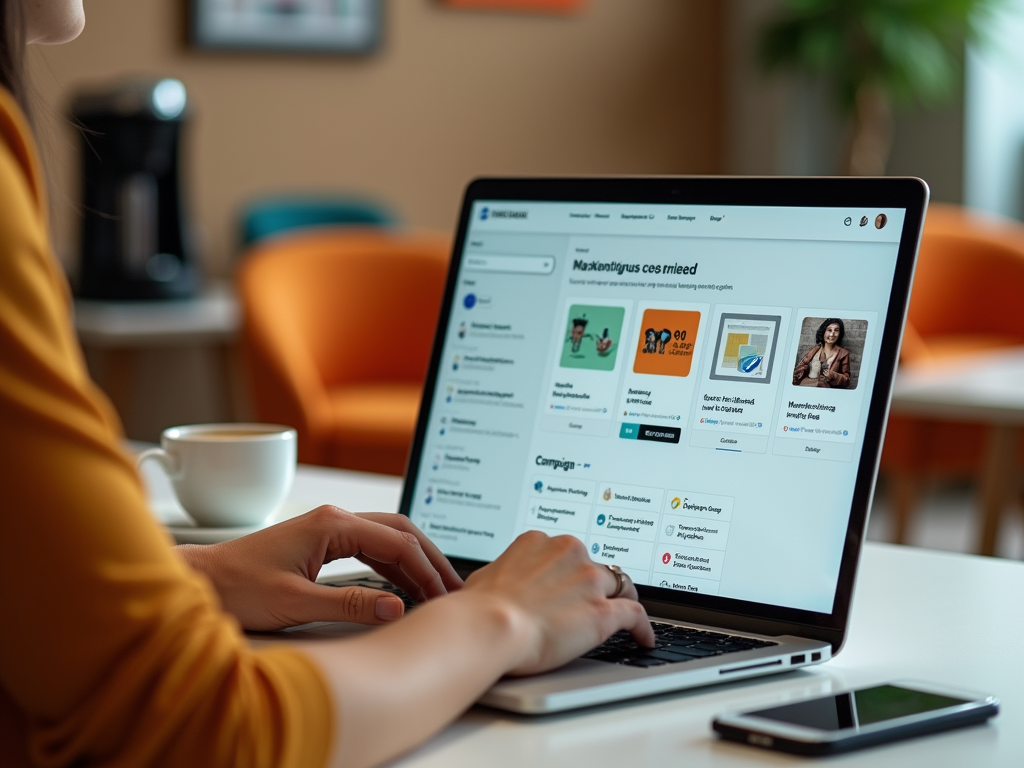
left=176, top=506, right=462, bottom=630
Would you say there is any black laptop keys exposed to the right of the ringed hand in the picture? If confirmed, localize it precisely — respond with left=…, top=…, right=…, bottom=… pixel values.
left=583, top=622, right=778, bottom=667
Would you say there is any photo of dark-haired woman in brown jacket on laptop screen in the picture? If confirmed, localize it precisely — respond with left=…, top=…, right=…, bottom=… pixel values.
left=793, top=317, right=867, bottom=389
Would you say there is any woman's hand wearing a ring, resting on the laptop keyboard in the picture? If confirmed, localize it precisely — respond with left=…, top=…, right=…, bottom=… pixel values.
left=464, top=530, right=654, bottom=675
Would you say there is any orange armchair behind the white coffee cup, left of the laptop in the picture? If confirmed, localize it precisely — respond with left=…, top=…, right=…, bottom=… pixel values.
left=238, top=229, right=451, bottom=475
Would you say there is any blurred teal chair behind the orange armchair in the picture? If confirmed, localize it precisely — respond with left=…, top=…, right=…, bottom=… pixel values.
left=242, top=197, right=398, bottom=250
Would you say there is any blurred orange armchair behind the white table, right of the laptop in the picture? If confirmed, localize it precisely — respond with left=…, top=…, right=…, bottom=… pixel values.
left=882, top=204, right=1024, bottom=542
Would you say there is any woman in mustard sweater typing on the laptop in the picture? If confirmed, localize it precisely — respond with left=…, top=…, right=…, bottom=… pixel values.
left=0, top=0, right=653, bottom=768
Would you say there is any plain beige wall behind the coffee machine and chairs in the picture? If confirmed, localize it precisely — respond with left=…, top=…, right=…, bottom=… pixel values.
left=31, top=0, right=723, bottom=273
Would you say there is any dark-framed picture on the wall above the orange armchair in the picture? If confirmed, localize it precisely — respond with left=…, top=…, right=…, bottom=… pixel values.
left=189, top=0, right=381, bottom=53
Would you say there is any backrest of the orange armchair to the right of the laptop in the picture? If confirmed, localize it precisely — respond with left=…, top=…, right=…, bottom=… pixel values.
left=904, top=204, right=1024, bottom=356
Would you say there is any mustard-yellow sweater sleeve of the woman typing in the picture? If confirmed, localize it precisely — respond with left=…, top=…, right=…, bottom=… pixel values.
left=0, top=92, right=333, bottom=768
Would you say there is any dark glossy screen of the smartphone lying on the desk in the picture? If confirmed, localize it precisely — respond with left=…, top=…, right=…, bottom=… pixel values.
left=746, top=685, right=969, bottom=731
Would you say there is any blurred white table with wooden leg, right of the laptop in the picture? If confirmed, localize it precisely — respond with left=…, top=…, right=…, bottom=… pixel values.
left=892, top=348, right=1024, bottom=557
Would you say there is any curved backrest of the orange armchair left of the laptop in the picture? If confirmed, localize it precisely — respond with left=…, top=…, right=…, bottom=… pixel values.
left=238, top=228, right=451, bottom=447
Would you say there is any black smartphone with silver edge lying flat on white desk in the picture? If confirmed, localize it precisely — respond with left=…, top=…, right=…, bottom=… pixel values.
left=712, top=682, right=999, bottom=755
